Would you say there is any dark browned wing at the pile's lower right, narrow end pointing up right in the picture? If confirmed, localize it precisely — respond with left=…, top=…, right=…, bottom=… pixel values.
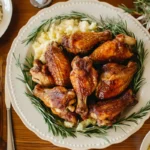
left=90, top=90, right=136, bottom=126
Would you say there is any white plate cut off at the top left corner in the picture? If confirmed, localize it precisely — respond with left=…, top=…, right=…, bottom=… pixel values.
left=0, top=0, right=12, bottom=37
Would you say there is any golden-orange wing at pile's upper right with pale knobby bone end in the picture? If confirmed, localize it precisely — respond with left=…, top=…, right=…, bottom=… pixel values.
left=90, top=34, right=136, bottom=62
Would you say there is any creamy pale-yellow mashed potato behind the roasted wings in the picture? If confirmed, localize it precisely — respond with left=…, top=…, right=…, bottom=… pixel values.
left=32, top=19, right=97, bottom=63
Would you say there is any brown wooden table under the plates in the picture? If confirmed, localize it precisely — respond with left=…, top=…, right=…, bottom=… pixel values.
left=0, top=0, right=150, bottom=150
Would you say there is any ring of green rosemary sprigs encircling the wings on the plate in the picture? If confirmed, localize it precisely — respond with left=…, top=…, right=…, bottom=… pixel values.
left=14, top=12, right=150, bottom=138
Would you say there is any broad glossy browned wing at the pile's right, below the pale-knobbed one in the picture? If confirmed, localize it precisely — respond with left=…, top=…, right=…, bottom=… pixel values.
left=96, top=62, right=137, bottom=99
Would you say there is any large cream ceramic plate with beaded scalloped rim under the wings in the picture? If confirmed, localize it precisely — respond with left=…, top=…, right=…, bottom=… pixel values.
left=7, top=0, right=150, bottom=150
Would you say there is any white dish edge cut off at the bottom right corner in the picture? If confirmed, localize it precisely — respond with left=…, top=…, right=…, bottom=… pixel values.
left=140, top=132, right=150, bottom=150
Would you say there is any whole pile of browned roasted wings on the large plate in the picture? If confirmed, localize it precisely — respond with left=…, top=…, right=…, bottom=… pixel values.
left=30, top=31, right=137, bottom=126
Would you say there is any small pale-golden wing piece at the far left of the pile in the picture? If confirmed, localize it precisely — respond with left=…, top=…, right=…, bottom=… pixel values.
left=30, top=59, right=55, bottom=87
